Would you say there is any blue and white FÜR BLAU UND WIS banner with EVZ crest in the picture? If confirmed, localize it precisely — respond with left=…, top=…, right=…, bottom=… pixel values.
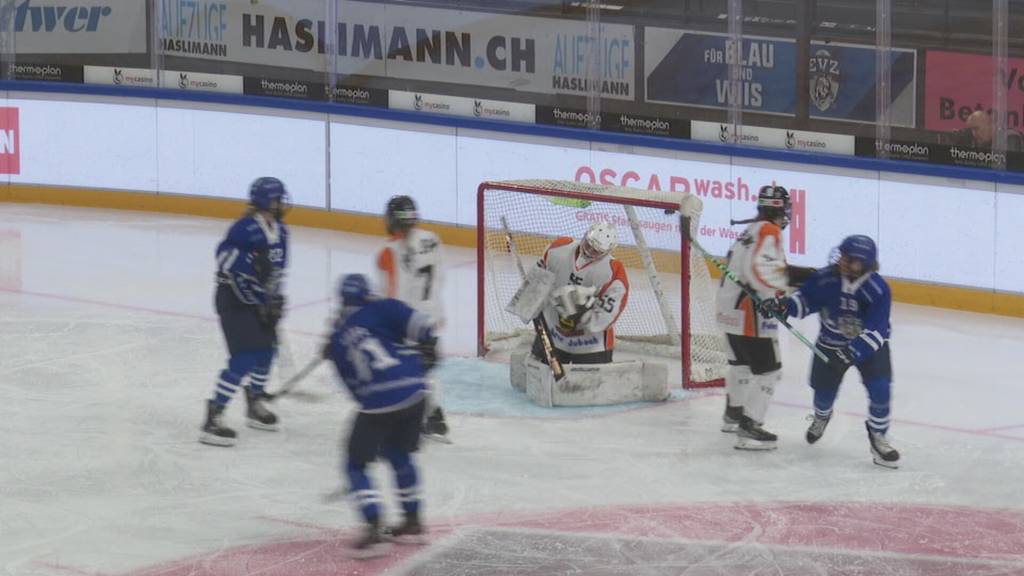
left=644, top=28, right=916, bottom=126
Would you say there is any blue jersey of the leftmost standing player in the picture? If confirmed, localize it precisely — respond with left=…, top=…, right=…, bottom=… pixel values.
left=217, top=214, right=288, bottom=305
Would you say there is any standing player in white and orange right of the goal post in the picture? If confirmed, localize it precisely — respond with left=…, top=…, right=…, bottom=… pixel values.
left=716, top=184, right=814, bottom=450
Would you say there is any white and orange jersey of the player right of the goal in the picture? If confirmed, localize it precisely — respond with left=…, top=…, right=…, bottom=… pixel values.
left=716, top=220, right=788, bottom=338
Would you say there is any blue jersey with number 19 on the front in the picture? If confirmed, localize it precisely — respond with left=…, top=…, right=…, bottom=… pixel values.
left=786, top=265, right=892, bottom=363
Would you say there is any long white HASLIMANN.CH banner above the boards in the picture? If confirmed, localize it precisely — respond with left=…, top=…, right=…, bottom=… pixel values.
left=161, top=0, right=636, bottom=100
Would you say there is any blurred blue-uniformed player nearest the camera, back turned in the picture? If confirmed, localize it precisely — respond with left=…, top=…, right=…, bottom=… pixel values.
left=324, top=274, right=437, bottom=558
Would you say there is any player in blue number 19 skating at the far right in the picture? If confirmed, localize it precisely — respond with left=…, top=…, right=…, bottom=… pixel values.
left=761, top=235, right=899, bottom=468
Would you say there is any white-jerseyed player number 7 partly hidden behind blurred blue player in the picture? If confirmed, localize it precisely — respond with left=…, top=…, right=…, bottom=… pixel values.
left=377, top=196, right=447, bottom=440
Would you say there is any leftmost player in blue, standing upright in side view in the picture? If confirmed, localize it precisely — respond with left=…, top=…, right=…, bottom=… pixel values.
left=200, top=177, right=288, bottom=446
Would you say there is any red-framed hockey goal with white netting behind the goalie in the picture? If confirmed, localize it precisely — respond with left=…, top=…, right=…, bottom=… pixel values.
left=476, top=180, right=726, bottom=387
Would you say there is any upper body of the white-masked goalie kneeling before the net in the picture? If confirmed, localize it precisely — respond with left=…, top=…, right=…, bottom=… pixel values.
left=531, top=222, right=630, bottom=364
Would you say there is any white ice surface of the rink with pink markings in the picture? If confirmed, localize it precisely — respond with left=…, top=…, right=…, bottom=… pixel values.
left=0, top=204, right=1024, bottom=576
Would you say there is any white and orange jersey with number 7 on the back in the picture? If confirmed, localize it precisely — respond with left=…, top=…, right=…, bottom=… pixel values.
left=377, top=228, right=444, bottom=325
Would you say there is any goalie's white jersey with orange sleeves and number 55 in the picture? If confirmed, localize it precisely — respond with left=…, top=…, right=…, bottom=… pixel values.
left=537, top=237, right=630, bottom=354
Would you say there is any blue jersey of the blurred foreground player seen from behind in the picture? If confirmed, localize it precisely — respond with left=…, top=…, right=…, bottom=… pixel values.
left=328, top=298, right=434, bottom=412
